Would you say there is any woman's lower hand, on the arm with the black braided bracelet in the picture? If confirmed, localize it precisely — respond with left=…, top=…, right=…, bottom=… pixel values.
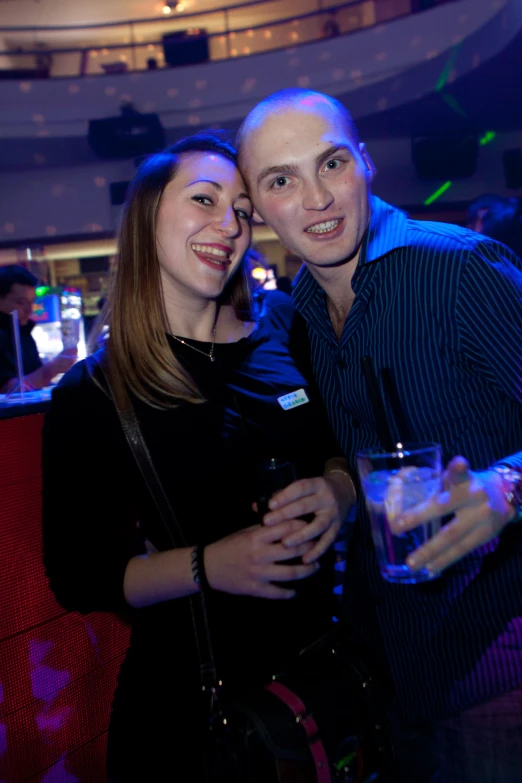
left=204, top=519, right=319, bottom=599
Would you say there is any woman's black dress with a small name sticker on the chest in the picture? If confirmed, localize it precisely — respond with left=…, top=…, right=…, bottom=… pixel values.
left=43, top=298, right=340, bottom=781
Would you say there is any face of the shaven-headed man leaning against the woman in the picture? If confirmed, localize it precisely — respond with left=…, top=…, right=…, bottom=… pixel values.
left=242, top=102, right=373, bottom=269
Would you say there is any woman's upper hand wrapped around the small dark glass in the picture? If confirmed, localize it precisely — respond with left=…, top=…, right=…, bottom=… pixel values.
left=263, top=473, right=355, bottom=563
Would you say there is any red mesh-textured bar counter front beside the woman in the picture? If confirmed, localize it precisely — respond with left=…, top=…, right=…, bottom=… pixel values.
left=0, top=403, right=129, bottom=783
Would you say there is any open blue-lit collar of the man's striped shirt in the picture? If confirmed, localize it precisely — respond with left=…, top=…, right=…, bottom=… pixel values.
left=293, top=196, right=408, bottom=312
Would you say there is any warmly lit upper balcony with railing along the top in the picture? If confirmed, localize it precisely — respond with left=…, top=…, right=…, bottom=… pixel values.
left=0, top=0, right=454, bottom=79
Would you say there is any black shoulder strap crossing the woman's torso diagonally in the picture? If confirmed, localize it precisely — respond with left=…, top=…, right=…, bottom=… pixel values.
left=97, top=361, right=218, bottom=696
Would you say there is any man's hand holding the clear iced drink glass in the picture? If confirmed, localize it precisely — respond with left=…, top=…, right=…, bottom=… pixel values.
left=390, top=457, right=516, bottom=573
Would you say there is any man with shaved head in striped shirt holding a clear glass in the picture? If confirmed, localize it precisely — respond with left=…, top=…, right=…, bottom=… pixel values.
left=238, top=90, right=522, bottom=783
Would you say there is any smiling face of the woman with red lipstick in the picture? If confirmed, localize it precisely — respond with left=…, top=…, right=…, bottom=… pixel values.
left=156, top=152, right=252, bottom=304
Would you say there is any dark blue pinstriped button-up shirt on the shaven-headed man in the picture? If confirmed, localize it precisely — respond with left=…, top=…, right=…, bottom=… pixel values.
left=294, top=198, right=522, bottom=722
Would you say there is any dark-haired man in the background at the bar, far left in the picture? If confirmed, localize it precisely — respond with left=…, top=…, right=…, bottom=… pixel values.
left=0, top=264, right=76, bottom=394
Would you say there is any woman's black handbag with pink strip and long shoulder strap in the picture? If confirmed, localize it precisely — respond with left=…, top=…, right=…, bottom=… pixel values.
left=99, top=366, right=394, bottom=783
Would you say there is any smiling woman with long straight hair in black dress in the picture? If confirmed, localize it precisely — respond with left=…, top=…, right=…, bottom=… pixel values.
left=44, top=135, right=354, bottom=783
